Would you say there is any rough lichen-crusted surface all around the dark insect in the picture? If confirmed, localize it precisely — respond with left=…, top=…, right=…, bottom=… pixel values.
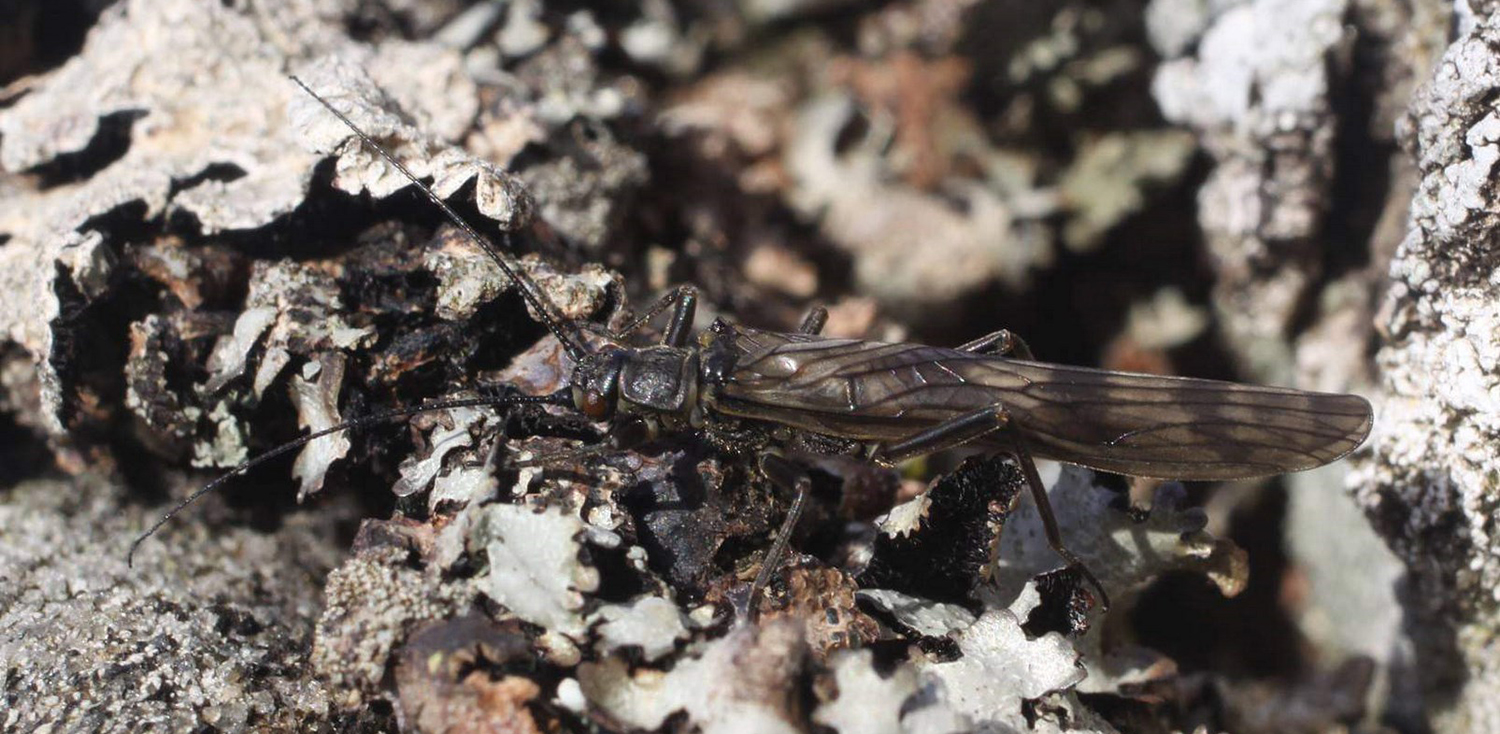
left=0, top=0, right=1464, bottom=732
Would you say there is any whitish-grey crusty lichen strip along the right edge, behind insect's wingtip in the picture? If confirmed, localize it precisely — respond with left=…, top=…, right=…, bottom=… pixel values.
left=1353, top=5, right=1500, bottom=731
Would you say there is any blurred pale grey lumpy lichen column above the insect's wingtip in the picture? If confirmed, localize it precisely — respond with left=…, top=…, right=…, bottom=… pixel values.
left=1154, top=0, right=1347, bottom=381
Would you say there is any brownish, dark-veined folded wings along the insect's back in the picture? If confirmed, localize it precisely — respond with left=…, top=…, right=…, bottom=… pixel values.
left=723, top=330, right=1373, bottom=480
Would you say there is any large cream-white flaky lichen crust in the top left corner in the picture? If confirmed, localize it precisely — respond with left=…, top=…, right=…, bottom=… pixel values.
left=0, top=2, right=530, bottom=434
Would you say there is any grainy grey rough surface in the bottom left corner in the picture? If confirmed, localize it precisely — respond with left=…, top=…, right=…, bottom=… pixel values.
left=0, top=479, right=353, bottom=731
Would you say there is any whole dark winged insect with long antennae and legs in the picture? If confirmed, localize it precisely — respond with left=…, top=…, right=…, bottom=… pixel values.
left=131, top=78, right=1373, bottom=611
